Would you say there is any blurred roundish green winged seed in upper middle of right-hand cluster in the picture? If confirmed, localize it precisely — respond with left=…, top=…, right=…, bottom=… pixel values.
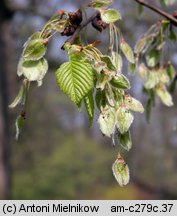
left=146, top=50, right=160, bottom=68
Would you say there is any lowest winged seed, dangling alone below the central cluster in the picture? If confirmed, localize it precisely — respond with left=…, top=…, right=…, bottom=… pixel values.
left=112, top=155, right=130, bottom=187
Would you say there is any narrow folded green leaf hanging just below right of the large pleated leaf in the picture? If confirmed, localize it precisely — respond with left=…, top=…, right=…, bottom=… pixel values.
left=84, top=90, right=94, bottom=125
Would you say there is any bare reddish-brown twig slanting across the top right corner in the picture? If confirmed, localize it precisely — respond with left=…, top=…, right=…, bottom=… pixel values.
left=133, top=0, right=177, bottom=27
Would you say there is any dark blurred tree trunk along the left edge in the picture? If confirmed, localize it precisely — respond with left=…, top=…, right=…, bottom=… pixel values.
left=0, top=1, right=12, bottom=199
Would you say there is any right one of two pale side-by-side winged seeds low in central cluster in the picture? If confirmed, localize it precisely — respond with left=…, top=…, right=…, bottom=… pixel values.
left=117, top=107, right=134, bottom=134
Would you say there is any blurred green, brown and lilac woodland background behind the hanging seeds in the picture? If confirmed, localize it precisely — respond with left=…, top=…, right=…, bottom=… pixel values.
left=0, top=0, right=177, bottom=199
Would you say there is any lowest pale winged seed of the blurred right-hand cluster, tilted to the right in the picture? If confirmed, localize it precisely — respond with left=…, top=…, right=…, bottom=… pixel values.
left=156, top=85, right=173, bottom=107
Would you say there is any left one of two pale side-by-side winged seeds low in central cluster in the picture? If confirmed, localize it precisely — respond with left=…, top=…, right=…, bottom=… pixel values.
left=98, top=106, right=116, bottom=137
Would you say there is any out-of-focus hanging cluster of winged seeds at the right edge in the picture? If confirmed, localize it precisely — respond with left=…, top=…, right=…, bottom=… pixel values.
left=135, top=20, right=176, bottom=121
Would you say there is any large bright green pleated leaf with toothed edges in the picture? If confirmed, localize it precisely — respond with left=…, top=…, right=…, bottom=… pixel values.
left=56, top=56, right=94, bottom=104
